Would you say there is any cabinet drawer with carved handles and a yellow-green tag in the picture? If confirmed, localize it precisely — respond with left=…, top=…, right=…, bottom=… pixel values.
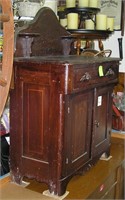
left=73, top=63, right=118, bottom=90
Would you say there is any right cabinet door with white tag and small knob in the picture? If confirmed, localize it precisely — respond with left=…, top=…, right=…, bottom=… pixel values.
left=92, top=87, right=112, bottom=156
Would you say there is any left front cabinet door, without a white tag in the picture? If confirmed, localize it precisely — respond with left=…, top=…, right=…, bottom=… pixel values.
left=64, top=91, right=93, bottom=173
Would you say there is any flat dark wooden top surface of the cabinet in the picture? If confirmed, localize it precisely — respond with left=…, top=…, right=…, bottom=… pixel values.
left=14, top=55, right=120, bottom=65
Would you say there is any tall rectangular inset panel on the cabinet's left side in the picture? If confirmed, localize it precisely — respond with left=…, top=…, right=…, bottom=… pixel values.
left=22, top=83, right=50, bottom=162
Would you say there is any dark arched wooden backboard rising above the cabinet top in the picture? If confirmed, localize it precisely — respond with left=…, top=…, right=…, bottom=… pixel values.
left=15, top=8, right=70, bottom=56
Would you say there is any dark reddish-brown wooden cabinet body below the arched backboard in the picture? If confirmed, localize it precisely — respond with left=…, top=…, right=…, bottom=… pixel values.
left=10, top=56, right=119, bottom=195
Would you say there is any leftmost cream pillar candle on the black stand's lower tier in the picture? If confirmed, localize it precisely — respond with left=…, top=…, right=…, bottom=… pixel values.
left=67, top=13, right=78, bottom=29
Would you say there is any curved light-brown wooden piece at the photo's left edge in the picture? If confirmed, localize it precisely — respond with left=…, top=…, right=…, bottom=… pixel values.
left=0, top=0, right=14, bottom=116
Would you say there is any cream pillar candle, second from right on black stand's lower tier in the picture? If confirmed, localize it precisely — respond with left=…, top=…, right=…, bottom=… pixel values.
left=96, top=14, right=107, bottom=30
